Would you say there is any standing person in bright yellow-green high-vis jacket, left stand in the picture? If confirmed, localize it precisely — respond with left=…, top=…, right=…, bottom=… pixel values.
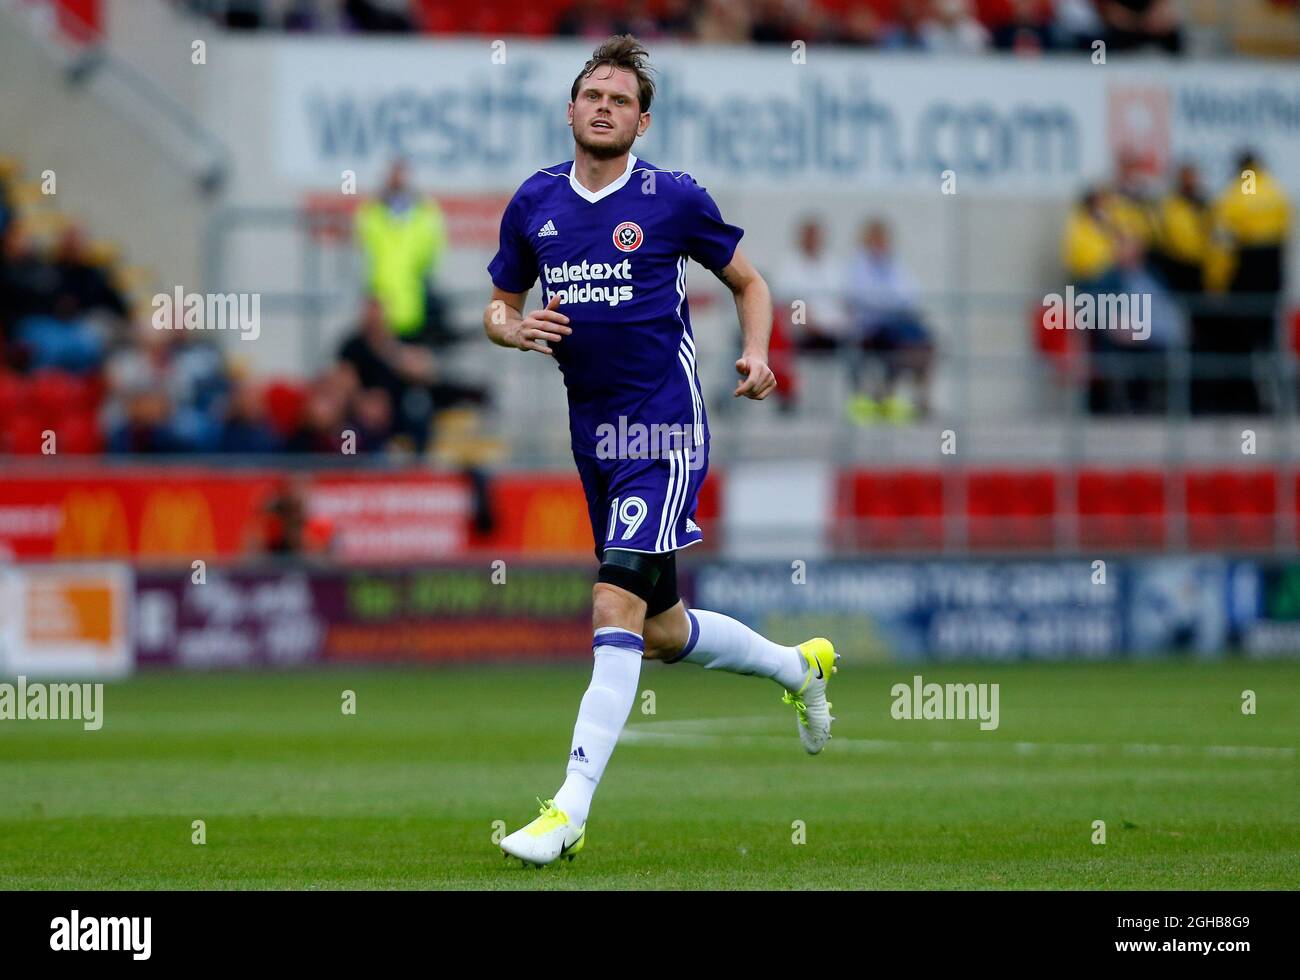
left=356, top=160, right=447, bottom=341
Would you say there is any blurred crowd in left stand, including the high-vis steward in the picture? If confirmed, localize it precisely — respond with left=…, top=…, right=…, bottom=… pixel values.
left=0, top=159, right=486, bottom=455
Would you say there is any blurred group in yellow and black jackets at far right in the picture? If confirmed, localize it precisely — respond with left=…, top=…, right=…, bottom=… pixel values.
left=1061, top=149, right=1291, bottom=415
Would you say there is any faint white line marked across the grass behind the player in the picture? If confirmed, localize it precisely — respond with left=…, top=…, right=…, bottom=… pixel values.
left=619, top=717, right=1296, bottom=760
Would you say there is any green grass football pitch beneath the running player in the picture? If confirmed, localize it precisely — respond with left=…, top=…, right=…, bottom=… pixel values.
left=0, top=662, right=1300, bottom=889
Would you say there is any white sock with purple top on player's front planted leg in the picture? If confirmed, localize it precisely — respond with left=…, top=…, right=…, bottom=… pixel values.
left=555, top=626, right=645, bottom=827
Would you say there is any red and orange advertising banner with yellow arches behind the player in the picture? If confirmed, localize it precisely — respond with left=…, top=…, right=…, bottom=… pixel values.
left=0, top=465, right=722, bottom=564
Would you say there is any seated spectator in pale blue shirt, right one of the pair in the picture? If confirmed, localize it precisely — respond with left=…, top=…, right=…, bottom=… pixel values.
left=845, top=218, right=935, bottom=425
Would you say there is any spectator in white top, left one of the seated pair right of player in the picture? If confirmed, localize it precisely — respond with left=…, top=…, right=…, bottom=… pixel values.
left=772, top=217, right=852, bottom=351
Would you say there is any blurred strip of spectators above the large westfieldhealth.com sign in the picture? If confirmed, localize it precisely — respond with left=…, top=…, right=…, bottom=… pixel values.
left=172, top=0, right=1183, bottom=55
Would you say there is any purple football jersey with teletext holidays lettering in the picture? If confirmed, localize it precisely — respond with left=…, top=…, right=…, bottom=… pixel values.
left=488, top=155, right=744, bottom=456
